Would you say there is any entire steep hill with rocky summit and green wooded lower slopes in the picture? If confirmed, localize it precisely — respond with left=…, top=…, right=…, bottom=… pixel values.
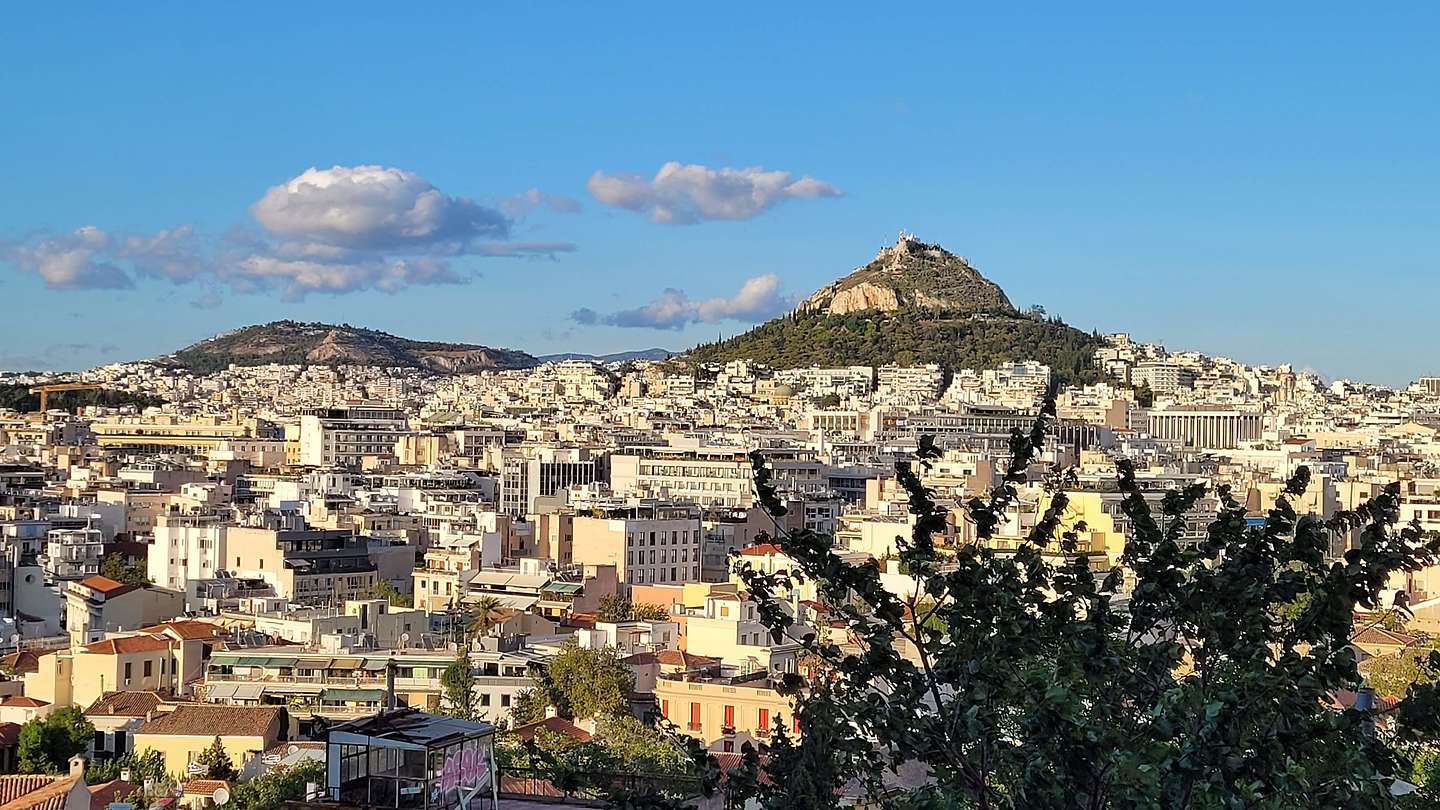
left=684, top=233, right=1103, bottom=382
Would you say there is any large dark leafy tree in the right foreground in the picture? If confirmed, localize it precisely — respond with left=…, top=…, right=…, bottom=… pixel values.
left=733, top=396, right=1440, bottom=810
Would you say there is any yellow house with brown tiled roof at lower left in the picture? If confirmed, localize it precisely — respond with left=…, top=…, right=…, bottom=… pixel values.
left=132, top=703, right=285, bottom=777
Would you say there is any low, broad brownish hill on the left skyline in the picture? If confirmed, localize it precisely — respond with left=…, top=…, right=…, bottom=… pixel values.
left=160, top=320, right=539, bottom=373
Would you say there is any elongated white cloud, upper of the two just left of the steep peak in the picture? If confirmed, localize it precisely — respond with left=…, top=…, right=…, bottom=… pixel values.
left=585, top=160, right=842, bottom=225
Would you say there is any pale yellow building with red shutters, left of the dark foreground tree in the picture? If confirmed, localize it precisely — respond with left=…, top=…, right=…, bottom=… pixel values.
left=655, top=673, right=799, bottom=751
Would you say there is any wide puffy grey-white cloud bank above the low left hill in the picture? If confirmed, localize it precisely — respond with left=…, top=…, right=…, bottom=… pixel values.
left=0, top=166, right=579, bottom=299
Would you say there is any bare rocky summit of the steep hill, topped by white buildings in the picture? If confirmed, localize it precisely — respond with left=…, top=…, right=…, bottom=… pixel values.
left=799, top=232, right=1015, bottom=316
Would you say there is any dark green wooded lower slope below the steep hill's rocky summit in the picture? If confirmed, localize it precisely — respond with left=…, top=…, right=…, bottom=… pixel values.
left=687, top=308, right=1103, bottom=383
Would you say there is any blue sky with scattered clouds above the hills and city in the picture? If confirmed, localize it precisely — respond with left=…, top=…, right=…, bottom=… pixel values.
left=0, top=3, right=1440, bottom=382
